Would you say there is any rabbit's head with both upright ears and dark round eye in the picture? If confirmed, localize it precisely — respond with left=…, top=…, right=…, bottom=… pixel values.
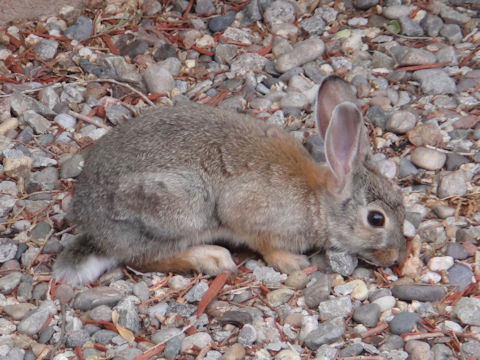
left=315, top=77, right=405, bottom=266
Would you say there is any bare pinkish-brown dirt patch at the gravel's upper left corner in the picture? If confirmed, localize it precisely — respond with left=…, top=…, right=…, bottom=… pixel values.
left=0, top=0, right=84, bottom=26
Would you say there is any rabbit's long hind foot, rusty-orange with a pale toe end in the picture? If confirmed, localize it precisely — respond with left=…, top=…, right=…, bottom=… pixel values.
left=129, top=245, right=237, bottom=275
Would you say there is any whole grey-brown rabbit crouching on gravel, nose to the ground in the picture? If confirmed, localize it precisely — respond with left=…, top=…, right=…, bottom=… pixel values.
left=54, top=76, right=405, bottom=285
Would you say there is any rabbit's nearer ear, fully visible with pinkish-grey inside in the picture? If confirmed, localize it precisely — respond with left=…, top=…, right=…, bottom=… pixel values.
left=325, top=101, right=368, bottom=193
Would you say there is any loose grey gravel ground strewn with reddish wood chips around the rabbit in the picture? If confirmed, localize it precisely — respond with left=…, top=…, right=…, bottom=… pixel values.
left=0, top=0, right=480, bottom=360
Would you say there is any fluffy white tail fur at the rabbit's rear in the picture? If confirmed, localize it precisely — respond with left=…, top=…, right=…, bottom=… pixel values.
left=54, top=255, right=118, bottom=285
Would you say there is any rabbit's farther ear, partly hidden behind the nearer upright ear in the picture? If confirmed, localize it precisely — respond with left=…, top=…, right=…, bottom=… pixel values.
left=315, top=75, right=356, bottom=140
